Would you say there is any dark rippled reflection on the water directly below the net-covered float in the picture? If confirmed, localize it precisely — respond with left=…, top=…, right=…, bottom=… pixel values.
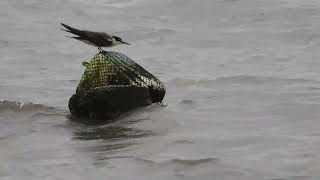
left=67, top=104, right=163, bottom=166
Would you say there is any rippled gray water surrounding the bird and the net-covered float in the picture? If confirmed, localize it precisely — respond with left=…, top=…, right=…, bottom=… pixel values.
left=0, top=0, right=320, bottom=180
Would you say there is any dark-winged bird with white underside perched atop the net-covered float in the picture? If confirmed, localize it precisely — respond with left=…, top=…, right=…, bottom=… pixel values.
left=61, top=23, right=131, bottom=52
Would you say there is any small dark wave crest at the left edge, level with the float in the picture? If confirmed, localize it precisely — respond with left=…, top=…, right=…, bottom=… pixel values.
left=0, top=100, right=54, bottom=112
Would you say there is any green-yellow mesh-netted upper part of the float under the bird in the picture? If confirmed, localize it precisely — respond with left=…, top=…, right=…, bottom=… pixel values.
left=77, top=52, right=165, bottom=102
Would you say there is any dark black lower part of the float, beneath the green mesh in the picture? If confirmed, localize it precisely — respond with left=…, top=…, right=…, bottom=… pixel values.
left=69, top=86, right=152, bottom=119
